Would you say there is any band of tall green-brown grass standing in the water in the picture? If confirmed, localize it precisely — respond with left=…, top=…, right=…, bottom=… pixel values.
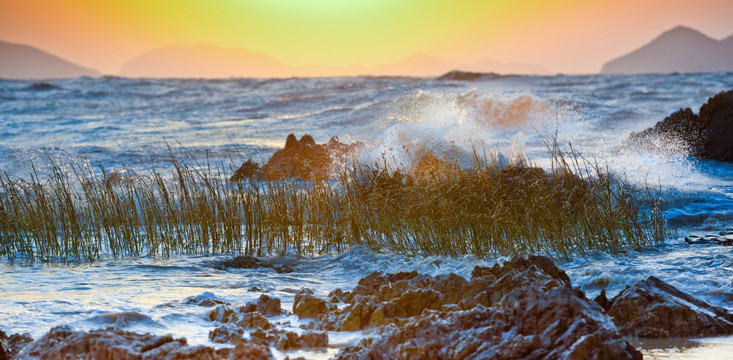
left=0, top=143, right=666, bottom=261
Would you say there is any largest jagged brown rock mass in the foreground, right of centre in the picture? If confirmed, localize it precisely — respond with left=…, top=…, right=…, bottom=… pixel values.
left=282, top=256, right=641, bottom=359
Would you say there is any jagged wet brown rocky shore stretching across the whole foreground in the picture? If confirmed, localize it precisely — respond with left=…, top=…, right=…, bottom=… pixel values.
left=5, top=256, right=733, bottom=360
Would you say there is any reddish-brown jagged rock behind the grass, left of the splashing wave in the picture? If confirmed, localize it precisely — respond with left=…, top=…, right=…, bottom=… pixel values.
left=230, top=134, right=360, bottom=181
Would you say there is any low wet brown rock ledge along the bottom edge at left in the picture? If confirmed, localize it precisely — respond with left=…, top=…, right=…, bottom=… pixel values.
left=14, top=326, right=272, bottom=360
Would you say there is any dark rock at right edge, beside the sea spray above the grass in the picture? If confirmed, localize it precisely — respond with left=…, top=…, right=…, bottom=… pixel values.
left=629, top=90, right=733, bottom=162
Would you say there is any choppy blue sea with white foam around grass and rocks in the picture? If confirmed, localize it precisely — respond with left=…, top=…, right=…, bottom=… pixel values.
left=0, top=73, right=733, bottom=359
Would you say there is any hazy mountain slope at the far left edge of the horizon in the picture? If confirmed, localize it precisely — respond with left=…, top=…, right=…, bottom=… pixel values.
left=0, top=41, right=101, bottom=79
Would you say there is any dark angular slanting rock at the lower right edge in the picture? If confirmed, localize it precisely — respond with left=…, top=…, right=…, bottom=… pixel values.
left=607, top=276, right=733, bottom=338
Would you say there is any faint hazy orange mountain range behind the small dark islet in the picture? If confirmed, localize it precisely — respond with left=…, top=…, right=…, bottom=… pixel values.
left=365, top=54, right=550, bottom=76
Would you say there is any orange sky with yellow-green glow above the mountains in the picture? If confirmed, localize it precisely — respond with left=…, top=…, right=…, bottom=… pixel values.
left=0, top=0, right=733, bottom=74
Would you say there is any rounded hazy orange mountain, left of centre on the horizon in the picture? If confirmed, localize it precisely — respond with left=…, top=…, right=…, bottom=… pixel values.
left=120, top=44, right=291, bottom=78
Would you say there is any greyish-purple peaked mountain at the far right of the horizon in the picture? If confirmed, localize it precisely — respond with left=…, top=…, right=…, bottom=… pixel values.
left=601, top=26, right=733, bottom=74
